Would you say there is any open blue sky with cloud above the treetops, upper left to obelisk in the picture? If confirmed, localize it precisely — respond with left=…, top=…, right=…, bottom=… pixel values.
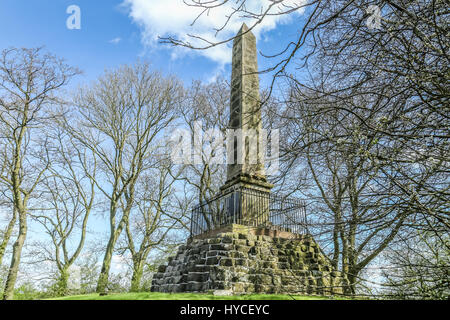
left=0, top=0, right=308, bottom=87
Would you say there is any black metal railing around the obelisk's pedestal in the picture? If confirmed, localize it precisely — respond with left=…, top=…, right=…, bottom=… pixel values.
left=190, top=188, right=307, bottom=237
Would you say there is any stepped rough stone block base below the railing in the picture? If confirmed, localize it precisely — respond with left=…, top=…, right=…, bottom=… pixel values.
left=151, top=232, right=344, bottom=295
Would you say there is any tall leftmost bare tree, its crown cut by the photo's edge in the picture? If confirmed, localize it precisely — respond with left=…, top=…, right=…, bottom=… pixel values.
left=0, top=48, right=78, bottom=300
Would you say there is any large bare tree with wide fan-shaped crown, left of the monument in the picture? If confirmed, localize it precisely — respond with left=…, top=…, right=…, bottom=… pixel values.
left=66, top=63, right=181, bottom=293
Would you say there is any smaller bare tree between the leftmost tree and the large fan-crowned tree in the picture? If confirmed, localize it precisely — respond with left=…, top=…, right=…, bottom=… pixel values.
left=31, top=127, right=97, bottom=295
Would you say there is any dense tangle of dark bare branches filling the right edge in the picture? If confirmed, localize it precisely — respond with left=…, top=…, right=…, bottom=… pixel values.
left=278, top=1, right=450, bottom=298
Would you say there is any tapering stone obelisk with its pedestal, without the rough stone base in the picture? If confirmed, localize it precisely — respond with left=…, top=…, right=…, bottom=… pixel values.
left=221, top=23, right=273, bottom=226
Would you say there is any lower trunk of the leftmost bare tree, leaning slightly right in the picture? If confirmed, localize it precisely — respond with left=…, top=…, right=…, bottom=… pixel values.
left=3, top=212, right=28, bottom=300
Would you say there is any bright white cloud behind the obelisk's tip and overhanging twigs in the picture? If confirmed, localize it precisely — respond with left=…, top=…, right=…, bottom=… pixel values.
left=123, top=0, right=307, bottom=65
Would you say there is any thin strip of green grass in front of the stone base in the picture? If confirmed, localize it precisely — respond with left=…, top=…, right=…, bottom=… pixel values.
left=48, top=292, right=343, bottom=300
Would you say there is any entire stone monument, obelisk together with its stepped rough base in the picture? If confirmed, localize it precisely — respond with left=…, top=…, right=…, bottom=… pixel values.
left=151, top=24, right=345, bottom=295
